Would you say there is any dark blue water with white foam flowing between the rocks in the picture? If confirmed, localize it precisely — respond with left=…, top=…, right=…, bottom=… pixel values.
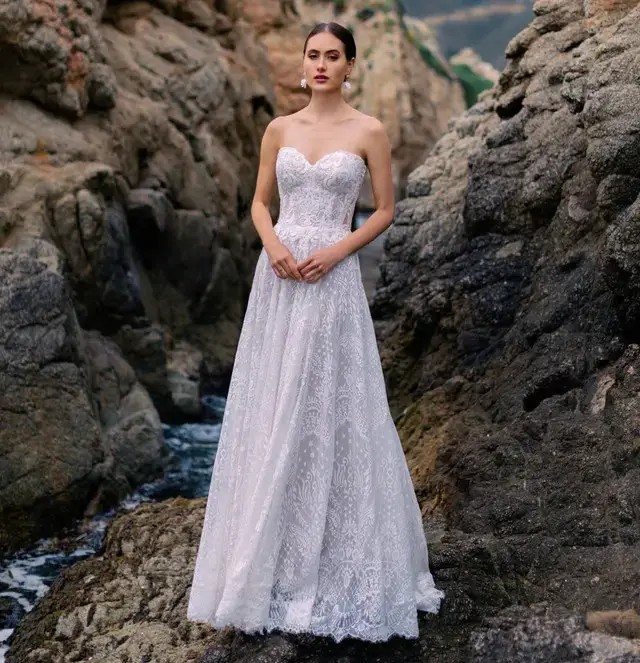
left=0, top=396, right=226, bottom=663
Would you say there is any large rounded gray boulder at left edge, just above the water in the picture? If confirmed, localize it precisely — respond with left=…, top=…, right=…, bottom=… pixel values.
left=0, top=246, right=164, bottom=552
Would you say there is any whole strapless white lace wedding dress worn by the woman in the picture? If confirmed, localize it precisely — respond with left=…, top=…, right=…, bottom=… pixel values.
left=187, top=147, right=444, bottom=641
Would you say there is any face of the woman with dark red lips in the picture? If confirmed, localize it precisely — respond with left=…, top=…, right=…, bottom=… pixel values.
left=302, top=32, right=355, bottom=90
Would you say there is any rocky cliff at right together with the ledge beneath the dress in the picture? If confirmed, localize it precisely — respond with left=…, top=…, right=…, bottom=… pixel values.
left=9, top=0, right=640, bottom=663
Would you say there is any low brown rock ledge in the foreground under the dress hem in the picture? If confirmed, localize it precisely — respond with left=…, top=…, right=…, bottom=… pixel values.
left=7, top=498, right=640, bottom=663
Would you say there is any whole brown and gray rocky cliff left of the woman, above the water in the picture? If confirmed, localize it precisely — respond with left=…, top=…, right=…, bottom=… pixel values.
left=0, top=0, right=275, bottom=551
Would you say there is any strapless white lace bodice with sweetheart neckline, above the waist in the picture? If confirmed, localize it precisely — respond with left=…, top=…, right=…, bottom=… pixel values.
left=276, top=146, right=367, bottom=239
